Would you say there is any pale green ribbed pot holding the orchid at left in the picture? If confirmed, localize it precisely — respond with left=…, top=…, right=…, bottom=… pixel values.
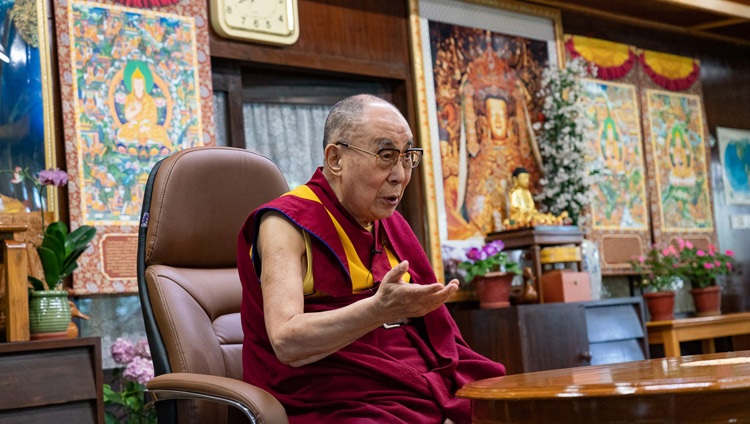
left=29, top=290, right=70, bottom=340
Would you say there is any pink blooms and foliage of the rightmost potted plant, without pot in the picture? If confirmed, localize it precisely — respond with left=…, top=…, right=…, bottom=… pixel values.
left=676, top=238, right=734, bottom=289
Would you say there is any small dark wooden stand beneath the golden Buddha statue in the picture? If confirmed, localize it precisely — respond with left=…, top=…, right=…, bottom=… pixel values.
left=485, top=225, right=583, bottom=303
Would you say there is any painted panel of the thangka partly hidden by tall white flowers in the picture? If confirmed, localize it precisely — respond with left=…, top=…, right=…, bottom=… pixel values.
left=582, top=80, right=649, bottom=230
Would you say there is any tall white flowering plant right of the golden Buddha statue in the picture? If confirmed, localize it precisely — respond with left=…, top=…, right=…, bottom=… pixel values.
left=534, top=58, right=602, bottom=229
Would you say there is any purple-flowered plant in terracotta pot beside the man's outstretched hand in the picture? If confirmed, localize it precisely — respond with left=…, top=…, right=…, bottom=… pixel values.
left=459, top=240, right=521, bottom=309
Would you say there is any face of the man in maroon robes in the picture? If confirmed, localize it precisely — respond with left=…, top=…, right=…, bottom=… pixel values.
left=339, top=101, right=413, bottom=226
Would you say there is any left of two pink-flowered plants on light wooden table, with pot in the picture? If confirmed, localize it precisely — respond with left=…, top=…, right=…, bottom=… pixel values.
left=630, top=245, right=682, bottom=321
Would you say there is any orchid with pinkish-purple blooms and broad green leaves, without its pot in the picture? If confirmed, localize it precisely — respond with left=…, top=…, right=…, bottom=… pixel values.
left=2, top=166, right=96, bottom=290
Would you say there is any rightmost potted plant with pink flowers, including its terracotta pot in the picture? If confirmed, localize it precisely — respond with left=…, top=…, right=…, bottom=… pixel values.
left=677, top=238, right=734, bottom=316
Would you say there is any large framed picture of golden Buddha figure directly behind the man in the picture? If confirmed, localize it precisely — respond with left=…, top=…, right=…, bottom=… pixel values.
left=410, top=0, right=561, bottom=281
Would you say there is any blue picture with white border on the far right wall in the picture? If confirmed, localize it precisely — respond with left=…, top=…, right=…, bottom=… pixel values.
left=716, top=127, right=750, bottom=205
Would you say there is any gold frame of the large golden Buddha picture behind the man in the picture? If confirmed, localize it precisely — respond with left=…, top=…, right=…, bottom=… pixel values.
left=409, top=0, right=565, bottom=283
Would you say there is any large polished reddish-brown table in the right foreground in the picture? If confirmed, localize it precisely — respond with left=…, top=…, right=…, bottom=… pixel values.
left=458, top=351, right=750, bottom=424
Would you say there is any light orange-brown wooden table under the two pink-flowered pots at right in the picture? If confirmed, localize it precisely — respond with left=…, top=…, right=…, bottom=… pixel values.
left=646, top=312, right=750, bottom=356
